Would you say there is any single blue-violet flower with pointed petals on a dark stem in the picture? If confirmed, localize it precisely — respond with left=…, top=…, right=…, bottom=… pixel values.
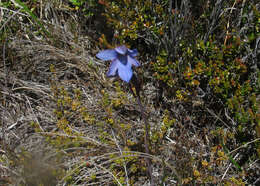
left=96, top=45, right=140, bottom=83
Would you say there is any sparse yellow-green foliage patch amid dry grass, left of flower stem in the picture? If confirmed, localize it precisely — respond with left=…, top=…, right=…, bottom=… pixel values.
left=46, top=65, right=95, bottom=148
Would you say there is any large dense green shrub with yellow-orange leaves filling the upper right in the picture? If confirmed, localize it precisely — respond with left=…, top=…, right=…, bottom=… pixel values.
left=98, top=0, right=259, bottom=181
